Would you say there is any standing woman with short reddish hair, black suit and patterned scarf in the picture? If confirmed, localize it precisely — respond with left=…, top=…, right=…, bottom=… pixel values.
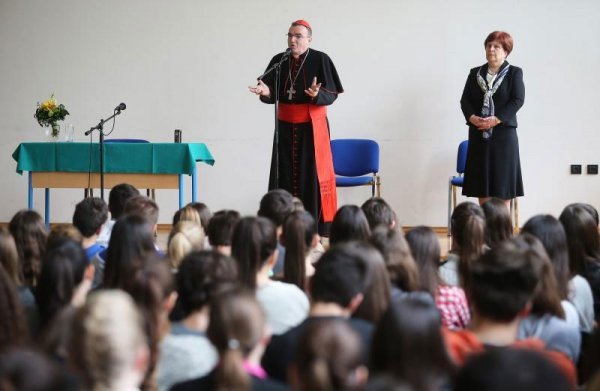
left=460, top=31, right=525, bottom=205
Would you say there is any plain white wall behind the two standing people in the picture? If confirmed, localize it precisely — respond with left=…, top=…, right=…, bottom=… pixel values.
left=0, top=0, right=600, bottom=226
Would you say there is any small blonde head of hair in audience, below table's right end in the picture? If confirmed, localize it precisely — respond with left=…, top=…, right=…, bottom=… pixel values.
left=167, top=221, right=204, bottom=269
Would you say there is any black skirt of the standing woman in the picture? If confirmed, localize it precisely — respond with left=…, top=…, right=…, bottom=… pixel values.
left=462, top=126, right=524, bottom=200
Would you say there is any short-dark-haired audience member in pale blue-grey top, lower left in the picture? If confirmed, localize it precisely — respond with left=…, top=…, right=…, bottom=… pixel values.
left=158, top=251, right=237, bottom=390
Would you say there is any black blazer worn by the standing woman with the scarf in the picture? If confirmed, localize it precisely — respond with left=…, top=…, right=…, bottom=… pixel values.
left=460, top=61, right=525, bottom=128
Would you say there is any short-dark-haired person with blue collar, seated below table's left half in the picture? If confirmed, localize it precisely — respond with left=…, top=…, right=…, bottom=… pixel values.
left=73, top=197, right=108, bottom=260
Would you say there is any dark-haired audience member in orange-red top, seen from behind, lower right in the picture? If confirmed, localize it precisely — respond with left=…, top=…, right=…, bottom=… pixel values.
left=443, top=238, right=576, bottom=386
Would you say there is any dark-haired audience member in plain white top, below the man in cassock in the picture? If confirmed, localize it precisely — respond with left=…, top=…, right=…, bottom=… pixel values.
left=232, top=217, right=308, bottom=335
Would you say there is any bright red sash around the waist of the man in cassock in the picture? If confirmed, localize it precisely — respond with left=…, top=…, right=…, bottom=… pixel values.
left=279, top=103, right=337, bottom=222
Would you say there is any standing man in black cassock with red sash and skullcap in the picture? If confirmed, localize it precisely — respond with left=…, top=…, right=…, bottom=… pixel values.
left=250, top=20, right=343, bottom=233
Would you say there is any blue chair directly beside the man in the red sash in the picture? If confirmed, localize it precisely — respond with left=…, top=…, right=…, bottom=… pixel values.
left=331, top=139, right=381, bottom=197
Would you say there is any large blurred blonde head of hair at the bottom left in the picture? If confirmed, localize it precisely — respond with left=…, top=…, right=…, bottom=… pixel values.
left=69, top=290, right=146, bottom=390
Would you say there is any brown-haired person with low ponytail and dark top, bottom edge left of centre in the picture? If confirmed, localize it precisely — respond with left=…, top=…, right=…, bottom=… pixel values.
left=172, top=291, right=286, bottom=391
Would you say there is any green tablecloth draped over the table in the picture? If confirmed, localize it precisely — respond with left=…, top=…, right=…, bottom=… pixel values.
left=12, top=142, right=215, bottom=175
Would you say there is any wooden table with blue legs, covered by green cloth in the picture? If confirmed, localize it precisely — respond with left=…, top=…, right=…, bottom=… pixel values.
left=12, top=142, right=215, bottom=224
